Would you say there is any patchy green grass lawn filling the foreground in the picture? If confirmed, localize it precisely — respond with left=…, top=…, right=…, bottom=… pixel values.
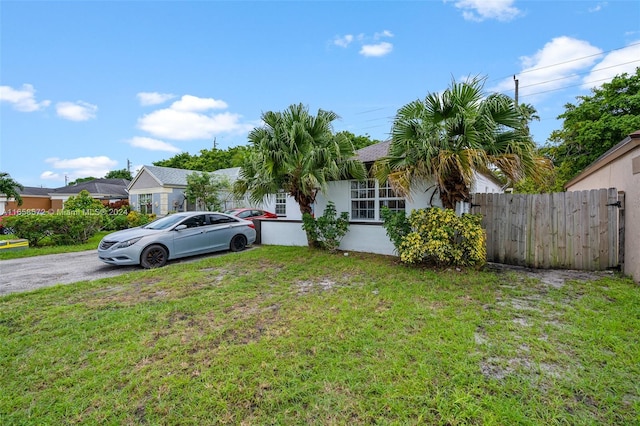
left=0, top=246, right=640, bottom=425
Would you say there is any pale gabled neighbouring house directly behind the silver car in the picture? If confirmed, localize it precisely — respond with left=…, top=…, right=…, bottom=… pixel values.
left=128, top=166, right=240, bottom=216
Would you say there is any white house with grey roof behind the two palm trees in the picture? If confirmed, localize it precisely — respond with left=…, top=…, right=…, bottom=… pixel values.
left=261, top=141, right=504, bottom=254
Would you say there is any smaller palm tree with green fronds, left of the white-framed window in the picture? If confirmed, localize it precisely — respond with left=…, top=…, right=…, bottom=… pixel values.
left=234, top=104, right=366, bottom=244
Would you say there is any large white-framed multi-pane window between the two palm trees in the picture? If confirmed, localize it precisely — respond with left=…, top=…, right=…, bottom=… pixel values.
left=351, top=179, right=405, bottom=220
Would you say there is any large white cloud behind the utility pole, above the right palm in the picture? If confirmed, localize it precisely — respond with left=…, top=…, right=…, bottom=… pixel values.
left=492, top=36, right=602, bottom=103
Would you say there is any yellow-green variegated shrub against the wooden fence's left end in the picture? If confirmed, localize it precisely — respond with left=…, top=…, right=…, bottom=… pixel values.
left=383, top=207, right=487, bottom=267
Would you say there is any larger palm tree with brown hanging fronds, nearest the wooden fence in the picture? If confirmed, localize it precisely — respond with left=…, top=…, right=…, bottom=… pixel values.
left=375, top=77, right=550, bottom=209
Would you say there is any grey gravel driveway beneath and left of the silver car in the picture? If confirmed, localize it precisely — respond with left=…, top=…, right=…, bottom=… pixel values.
left=0, top=250, right=241, bottom=296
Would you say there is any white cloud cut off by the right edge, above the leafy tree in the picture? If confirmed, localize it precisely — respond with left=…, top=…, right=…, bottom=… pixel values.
left=582, top=40, right=640, bottom=89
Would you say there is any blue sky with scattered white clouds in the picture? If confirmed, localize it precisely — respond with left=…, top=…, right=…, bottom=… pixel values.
left=0, top=0, right=640, bottom=188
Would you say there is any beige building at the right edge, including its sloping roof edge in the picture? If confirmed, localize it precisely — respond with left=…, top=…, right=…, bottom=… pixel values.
left=565, top=130, right=640, bottom=282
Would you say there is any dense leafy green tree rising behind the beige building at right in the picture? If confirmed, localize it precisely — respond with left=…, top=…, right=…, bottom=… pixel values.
left=545, top=67, right=640, bottom=189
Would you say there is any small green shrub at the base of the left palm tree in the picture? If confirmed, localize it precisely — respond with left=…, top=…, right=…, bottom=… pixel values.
left=302, top=201, right=349, bottom=252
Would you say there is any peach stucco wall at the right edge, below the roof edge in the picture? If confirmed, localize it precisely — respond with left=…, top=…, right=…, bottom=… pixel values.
left=567, top=146, right=640, bottom=282
